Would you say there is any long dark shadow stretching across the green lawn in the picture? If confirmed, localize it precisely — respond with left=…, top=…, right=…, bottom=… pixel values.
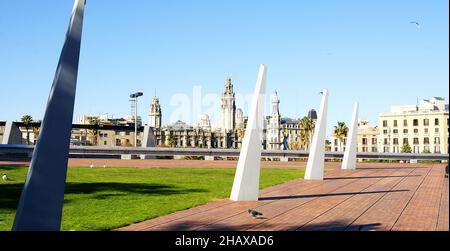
left=0, top=183, right=209, bottom=210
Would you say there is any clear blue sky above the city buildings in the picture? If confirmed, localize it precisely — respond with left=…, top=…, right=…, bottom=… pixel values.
left=0, top=0, right=449, bottom=137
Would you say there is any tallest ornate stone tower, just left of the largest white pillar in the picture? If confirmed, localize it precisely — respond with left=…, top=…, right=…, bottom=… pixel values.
left=221, top=77, right=236, bottom=132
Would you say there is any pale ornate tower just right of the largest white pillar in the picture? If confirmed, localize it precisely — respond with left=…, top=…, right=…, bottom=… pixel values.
left=267, top=91, right=282, bottom=150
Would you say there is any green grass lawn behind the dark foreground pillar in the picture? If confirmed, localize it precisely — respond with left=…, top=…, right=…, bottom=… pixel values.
left=0, top=166, right=304, bottom=231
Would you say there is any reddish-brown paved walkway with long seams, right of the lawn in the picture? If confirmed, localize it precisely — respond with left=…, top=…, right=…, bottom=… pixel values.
left=118, top=164, right=449, bottom=231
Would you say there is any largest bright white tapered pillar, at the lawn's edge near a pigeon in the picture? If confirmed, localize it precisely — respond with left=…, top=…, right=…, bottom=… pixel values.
left=230, top=65, right=267, bottom=201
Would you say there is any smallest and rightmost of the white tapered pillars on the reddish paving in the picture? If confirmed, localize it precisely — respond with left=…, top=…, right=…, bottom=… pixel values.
left=342, top=102, right=359, bottom=170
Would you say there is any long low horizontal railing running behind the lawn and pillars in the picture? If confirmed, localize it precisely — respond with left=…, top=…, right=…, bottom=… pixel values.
left=0, top=145, right=449, bottom=161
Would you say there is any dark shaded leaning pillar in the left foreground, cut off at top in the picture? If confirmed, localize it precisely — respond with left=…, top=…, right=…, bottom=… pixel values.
left=12, top=0, right=85, bottom=231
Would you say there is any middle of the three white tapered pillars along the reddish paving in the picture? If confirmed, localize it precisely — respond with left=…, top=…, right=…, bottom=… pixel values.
left=305, top=89, right=328, bottom=180
